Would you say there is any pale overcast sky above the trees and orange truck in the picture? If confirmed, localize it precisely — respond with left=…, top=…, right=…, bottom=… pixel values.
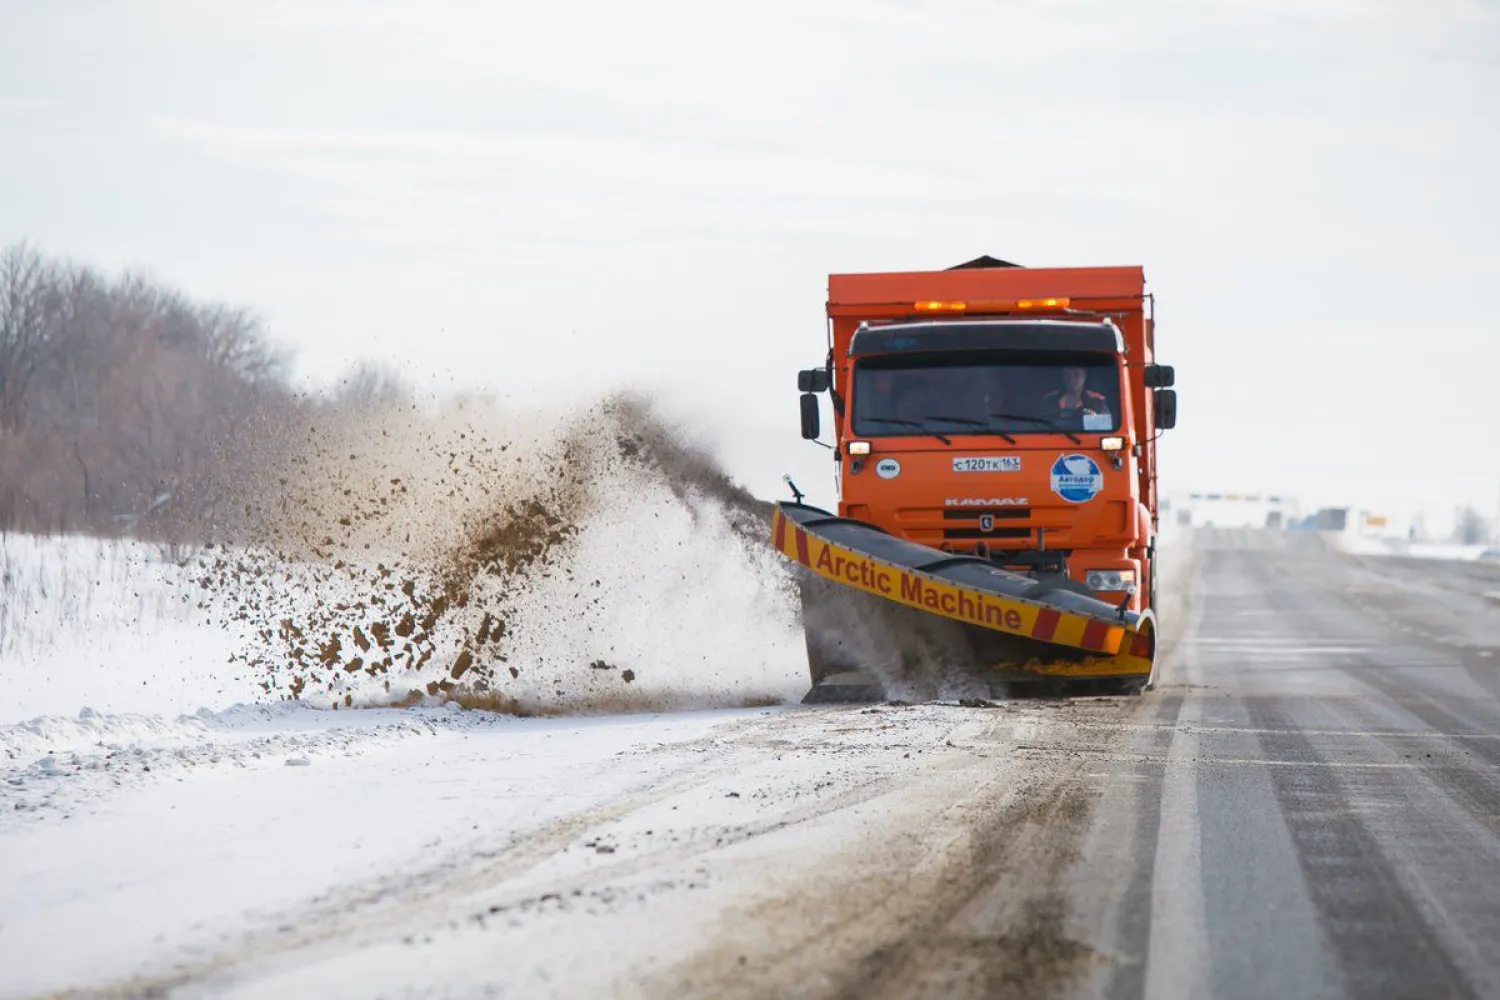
left=0, top=0, right=1500, bottom=524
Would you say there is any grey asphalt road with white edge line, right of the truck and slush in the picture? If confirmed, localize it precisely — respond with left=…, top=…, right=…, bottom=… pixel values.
left=1052, top=532, right=1500, bottom=997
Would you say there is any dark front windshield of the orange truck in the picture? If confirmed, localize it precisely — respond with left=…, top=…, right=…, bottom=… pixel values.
left=854, top=354, right=1121, bottom=438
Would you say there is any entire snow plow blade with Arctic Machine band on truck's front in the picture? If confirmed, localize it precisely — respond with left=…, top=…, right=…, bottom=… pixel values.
left=771, top=502, right=1155, bottom=703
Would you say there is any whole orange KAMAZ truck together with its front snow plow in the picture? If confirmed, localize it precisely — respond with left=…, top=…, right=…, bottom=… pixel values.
left=773, top=258, right=1176, bottom=702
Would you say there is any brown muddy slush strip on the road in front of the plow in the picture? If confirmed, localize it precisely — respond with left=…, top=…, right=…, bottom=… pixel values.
left=644, top=699, right=1142, bottom=1000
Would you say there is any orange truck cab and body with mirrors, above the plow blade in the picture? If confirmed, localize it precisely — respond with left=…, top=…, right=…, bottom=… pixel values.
left=798, top=258, right=1176, bottom=612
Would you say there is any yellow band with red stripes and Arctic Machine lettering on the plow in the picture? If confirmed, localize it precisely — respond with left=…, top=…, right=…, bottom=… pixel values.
left=771, top=510, right=1154, bottom=676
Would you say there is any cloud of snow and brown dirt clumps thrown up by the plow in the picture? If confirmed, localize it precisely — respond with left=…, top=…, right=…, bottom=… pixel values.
left=198, top=396, right=801, bottom=714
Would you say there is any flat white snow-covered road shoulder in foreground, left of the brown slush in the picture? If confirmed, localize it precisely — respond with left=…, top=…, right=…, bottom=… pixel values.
left=0, top=695, right=1092, bottom=997
